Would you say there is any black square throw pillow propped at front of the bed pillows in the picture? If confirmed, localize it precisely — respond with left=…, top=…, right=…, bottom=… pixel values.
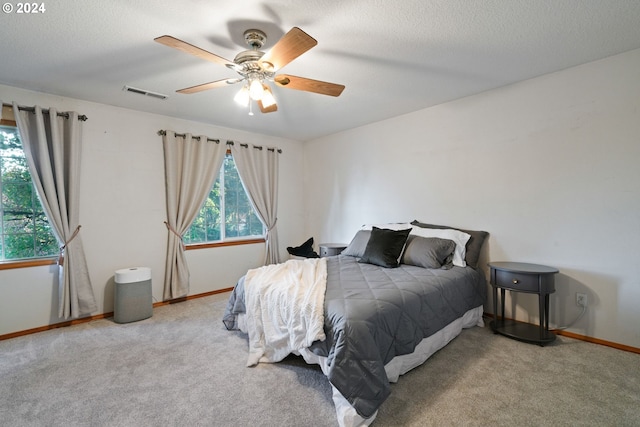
left=358, top=227, right=411, bottom=268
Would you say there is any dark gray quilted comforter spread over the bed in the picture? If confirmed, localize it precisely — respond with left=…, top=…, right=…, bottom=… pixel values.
left=223, top=255, right=486, bottom=418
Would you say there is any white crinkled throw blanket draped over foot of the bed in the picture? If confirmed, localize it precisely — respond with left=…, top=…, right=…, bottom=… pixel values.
left=244, top=258, right=327, bottom=366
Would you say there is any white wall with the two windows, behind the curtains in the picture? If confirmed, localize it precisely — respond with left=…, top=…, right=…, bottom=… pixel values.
left=0, top=85, right=304, bottom=335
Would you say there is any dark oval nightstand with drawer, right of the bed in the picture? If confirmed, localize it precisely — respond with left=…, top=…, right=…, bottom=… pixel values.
left=489, top=262, right=558, bottom=345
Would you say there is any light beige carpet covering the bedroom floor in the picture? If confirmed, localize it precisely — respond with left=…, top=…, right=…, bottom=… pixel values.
left=0, top=294, right=640, bottom=427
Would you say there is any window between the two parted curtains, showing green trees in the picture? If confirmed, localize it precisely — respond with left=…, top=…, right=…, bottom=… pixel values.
left=183, top=152, right=265, bottom=245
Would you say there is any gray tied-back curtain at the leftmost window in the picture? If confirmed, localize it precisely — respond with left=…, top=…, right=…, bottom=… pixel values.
left=13, top=103, right=98, bottom=319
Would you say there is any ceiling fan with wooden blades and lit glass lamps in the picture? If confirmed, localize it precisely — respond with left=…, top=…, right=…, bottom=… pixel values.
left=154, top=27, right=344, bottom=115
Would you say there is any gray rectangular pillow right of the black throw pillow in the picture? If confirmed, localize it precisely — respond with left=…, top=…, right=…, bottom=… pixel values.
left=401, top=236, right=456, bottom=270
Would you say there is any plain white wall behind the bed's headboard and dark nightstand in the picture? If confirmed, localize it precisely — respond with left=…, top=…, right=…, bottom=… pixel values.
left=305, top=50, right=640, bottom=347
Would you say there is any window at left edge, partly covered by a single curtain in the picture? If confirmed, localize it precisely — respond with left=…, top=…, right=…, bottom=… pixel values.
left=0, top=121, right=59, bottom=261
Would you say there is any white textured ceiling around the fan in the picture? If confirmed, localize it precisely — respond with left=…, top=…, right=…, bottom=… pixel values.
left=0, top=0, right=640, bottom=141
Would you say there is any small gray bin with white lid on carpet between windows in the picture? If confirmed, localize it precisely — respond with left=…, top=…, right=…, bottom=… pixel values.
left=113, top=267, right=153, bottom=323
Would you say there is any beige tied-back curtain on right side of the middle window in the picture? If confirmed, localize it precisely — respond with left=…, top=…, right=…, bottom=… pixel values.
left=231, top=144, right=280, bottom=265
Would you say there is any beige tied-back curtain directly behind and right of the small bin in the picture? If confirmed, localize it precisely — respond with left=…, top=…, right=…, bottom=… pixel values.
left=162, top=130, right=227, bottom=300
